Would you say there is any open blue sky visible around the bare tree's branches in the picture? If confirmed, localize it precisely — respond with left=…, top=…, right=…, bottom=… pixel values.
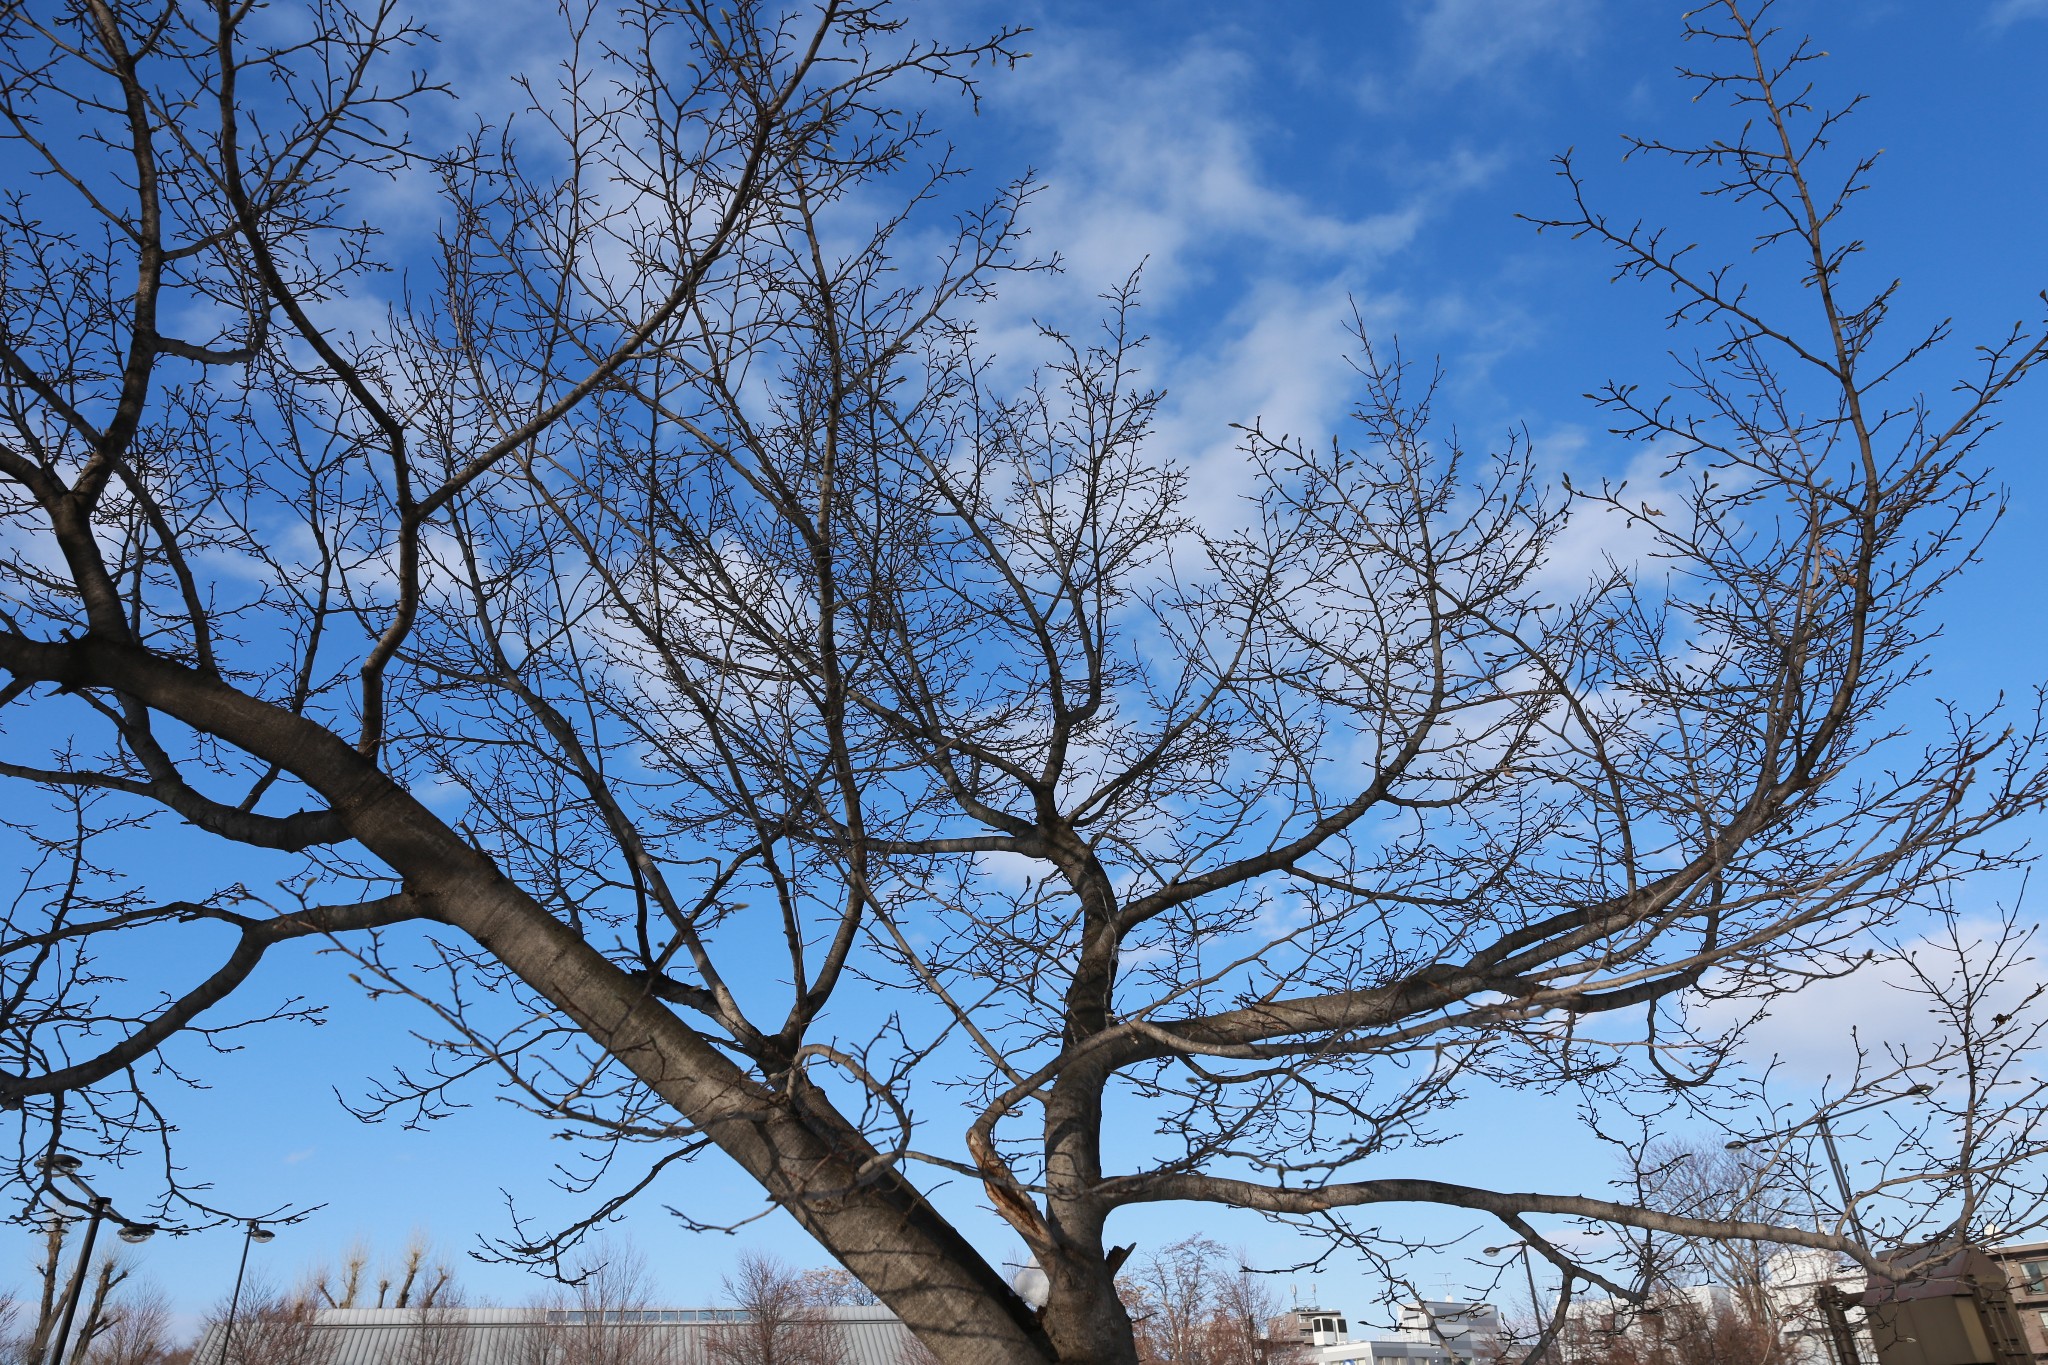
left=16, top=0, right=2048, bottom=1334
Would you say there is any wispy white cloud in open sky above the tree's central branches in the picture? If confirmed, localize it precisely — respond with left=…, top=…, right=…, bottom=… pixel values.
left=966, top=31, right=1495, bottom=524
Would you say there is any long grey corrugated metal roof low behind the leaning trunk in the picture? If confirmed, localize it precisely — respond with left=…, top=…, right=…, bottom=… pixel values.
left=193, top=1308, right=920, bottom=1365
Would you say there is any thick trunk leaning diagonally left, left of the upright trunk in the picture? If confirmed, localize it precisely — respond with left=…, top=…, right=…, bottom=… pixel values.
left=24, top=636, right=1056, bottom=1365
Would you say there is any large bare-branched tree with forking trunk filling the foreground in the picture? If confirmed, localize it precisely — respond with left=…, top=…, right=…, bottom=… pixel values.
left=0, top=0, right=2048, bottom=1365
